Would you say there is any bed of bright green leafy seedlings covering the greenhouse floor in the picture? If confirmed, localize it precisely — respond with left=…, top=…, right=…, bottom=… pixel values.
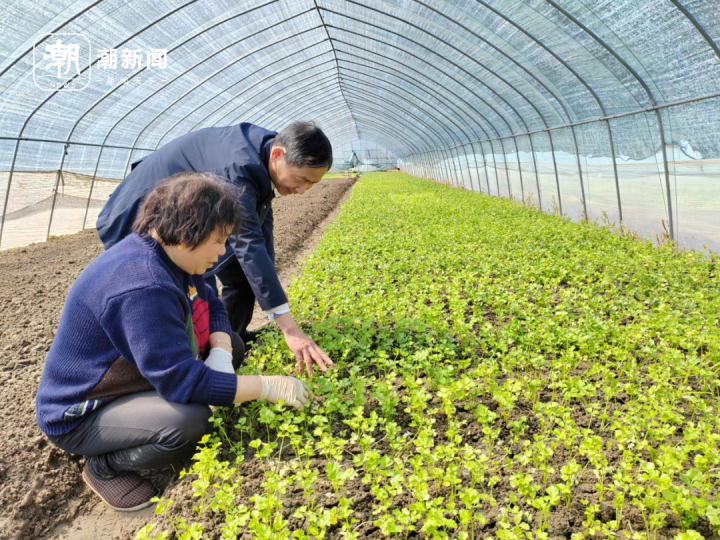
left=138, top=173, right=720, bottom=539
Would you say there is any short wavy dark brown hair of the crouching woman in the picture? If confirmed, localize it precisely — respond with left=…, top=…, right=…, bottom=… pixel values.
left=133, top=172, right=241, bottom=249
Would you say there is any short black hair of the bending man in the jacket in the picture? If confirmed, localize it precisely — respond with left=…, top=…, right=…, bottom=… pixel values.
left=273, top=122, right=332, bottom=169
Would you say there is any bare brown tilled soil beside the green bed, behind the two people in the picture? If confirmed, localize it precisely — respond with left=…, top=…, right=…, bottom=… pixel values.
left=0, top=175, right=354, bottom=539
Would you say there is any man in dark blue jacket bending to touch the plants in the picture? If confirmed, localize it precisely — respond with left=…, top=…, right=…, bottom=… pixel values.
left=97, top=122, right=332, bottom=374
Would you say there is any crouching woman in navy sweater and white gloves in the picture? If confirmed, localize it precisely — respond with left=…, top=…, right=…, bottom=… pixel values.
left=36, top=173, right=308, bottom=511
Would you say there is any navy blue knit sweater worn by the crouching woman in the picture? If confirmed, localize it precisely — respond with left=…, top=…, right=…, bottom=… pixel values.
left=35, top=234, right=237, bottom=435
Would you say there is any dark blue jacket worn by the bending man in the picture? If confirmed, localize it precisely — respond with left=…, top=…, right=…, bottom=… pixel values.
left=97, top=123, right=287, bottom=310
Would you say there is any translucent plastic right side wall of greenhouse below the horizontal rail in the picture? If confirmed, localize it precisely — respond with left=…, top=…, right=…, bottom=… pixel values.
left=401, top=96, right=720, bottom=252
